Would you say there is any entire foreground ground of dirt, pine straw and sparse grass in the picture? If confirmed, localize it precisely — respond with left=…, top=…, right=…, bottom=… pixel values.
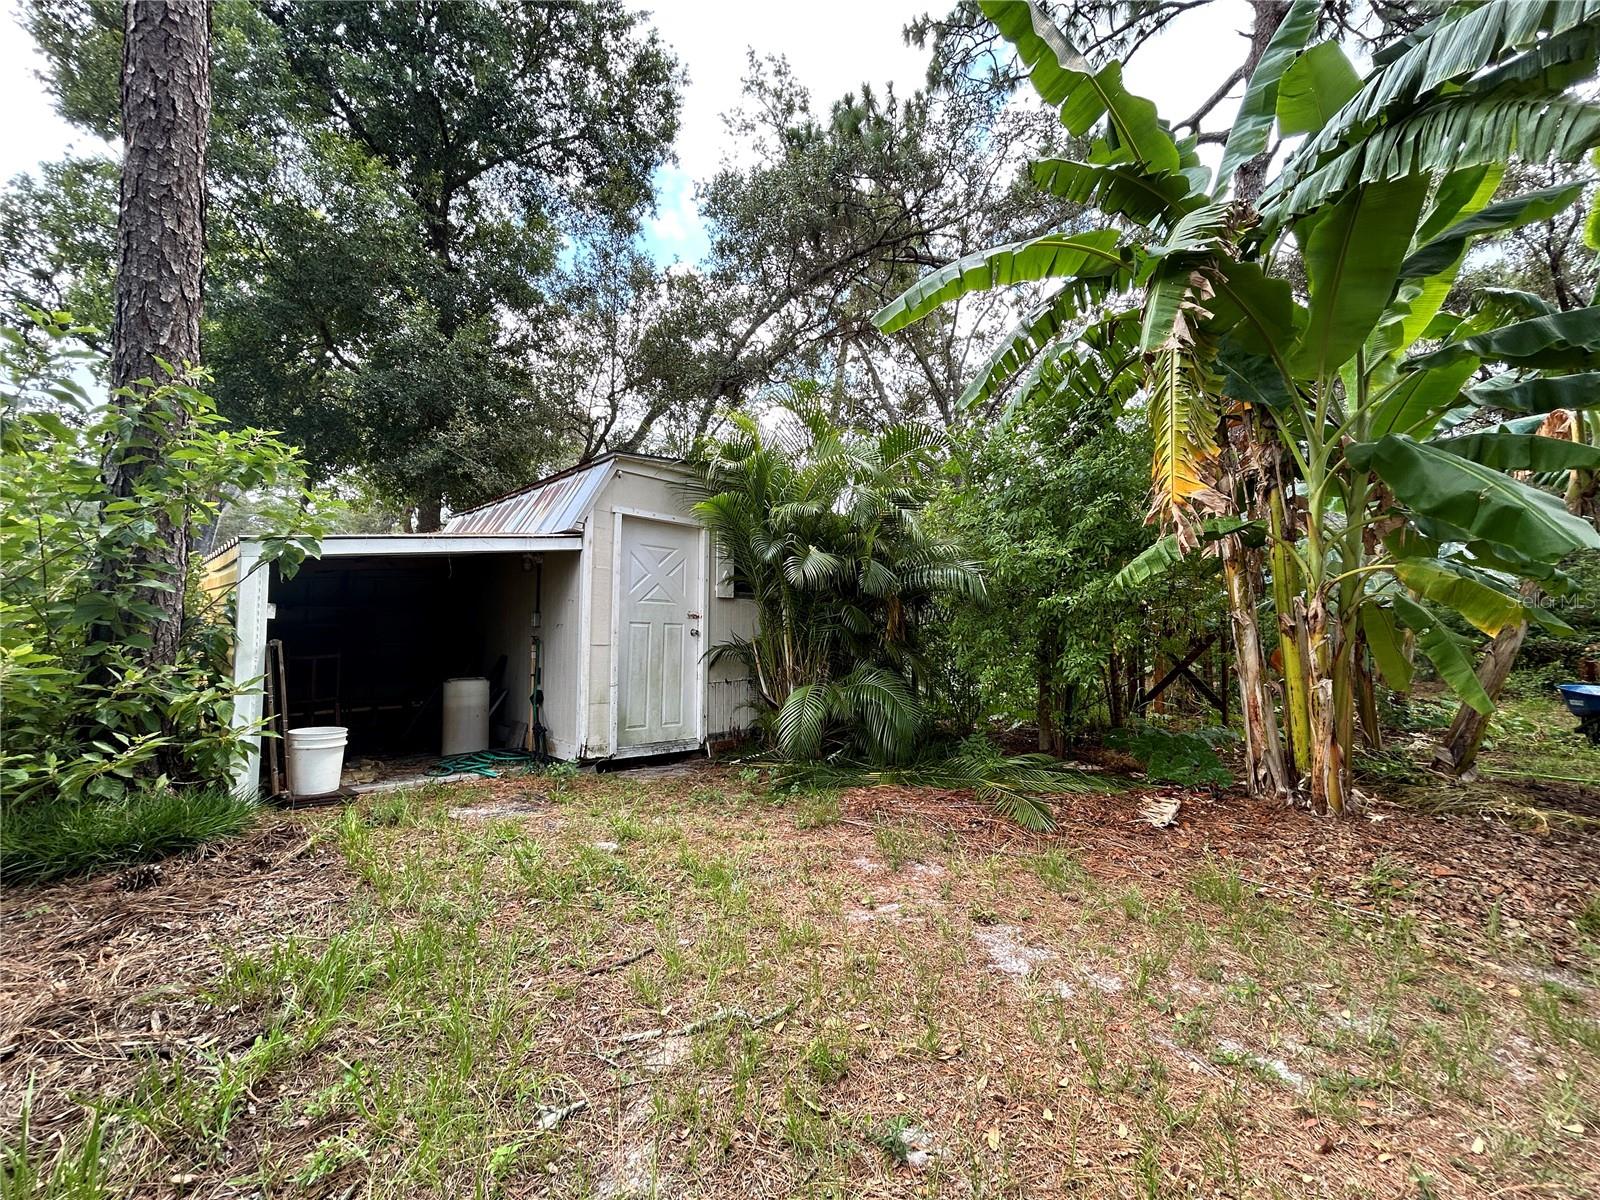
left=0, top=766, right=1600, bottom=1198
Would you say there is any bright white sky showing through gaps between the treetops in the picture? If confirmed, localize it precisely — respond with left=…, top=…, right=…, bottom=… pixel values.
left=0, top=0, right=1250, bottom=262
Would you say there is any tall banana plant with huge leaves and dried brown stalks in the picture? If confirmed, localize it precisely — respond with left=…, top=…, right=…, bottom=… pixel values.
left=877, top=0, right=1600, bottom=814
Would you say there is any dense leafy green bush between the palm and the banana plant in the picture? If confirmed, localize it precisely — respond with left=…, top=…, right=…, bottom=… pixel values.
left=928, top=378, right=1219, bottom=742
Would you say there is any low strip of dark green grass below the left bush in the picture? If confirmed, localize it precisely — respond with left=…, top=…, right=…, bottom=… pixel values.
left=0, top=787, right=258, bottom=883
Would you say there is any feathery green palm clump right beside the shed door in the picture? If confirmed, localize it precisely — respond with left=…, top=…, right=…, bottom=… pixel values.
left=694, top=400, right=984, bottom=763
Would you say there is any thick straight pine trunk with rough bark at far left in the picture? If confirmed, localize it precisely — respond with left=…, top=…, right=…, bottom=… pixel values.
left=106, top=0, right=211, bottom=667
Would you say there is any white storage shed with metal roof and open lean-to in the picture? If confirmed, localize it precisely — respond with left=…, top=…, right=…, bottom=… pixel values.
left=206, top=454, right=755, bottom=787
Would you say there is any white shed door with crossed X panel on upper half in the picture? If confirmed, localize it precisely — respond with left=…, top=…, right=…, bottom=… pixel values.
left=616, top=517, right=704, bottom=749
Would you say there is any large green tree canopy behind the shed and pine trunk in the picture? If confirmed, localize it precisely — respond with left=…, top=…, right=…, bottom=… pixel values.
left=0, top=0, right=678, bottom=526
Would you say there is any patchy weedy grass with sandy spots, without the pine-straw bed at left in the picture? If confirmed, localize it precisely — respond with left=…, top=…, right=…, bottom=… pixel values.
left=9, top=764, right=1600, bottom=1200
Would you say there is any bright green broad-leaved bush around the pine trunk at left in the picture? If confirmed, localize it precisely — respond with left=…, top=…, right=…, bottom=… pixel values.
left=0, top=314, right=323, bottom=819
